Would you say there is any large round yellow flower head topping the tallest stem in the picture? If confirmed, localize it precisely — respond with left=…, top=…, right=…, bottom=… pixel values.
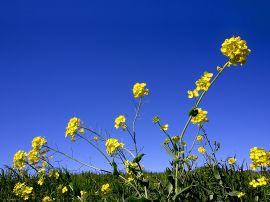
left=220, top=36, right=250, bottom=65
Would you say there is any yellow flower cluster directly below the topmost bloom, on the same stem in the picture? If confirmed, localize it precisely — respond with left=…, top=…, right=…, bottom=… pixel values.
left=188, top=72, right=213, bottom=98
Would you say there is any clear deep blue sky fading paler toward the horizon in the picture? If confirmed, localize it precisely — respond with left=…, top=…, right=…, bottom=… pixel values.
left=0, top=0, right=270, bottom=171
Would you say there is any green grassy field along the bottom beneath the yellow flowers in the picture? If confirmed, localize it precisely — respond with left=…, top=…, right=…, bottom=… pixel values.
left=0, top=167, right=270, bottom=202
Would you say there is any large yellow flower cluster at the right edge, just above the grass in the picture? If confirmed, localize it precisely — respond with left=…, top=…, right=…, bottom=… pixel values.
left=249, top=147, right=270, bottom=170
